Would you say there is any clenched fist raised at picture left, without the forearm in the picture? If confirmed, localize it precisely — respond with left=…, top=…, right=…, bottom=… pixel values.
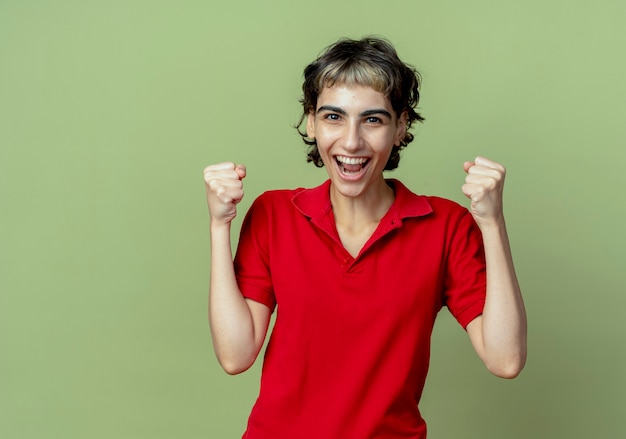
left=204, top=162, right=246, bottom=229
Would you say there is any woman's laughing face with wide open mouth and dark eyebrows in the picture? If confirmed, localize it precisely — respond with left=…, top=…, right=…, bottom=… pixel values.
left=307, top=84, right=406, bottom=201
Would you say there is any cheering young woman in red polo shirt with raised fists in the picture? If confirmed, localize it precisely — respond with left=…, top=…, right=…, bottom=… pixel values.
left=204, top=38, right=526, bottom=439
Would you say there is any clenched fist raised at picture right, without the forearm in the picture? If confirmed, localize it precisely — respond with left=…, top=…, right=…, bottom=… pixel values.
left=462, top=157, right=506, bottom=228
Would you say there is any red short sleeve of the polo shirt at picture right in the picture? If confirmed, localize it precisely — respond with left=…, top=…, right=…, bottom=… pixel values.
left=444, top=209, right=487, bottom=328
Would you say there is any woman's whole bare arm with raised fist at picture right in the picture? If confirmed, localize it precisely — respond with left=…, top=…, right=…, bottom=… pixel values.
left=463, top=157, right=527, bottom=378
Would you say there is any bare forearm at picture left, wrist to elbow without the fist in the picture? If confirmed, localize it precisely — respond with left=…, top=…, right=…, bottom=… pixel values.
left=209, top=224, right=262, bottom=373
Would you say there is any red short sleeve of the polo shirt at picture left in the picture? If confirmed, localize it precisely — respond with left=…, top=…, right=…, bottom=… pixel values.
left=234, top=195, right=276, bottom=311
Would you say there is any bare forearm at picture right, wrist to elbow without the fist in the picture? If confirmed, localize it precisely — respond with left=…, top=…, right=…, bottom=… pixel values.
left=470, top=218, right=526, bottom=378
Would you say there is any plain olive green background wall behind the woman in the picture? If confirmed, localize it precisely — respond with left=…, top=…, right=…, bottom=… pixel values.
left=0, top=0, right=626, bottom=439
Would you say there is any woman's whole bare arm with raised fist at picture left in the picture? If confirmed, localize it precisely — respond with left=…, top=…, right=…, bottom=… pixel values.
left=204, top=163, right=271, bottom=374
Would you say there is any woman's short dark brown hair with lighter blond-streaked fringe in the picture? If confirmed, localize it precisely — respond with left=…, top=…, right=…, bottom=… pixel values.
left=296, top=37, right=424, bottom=171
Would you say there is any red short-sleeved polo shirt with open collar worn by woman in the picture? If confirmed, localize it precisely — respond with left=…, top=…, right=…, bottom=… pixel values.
left=235, top=180, right=486, bottom=439
